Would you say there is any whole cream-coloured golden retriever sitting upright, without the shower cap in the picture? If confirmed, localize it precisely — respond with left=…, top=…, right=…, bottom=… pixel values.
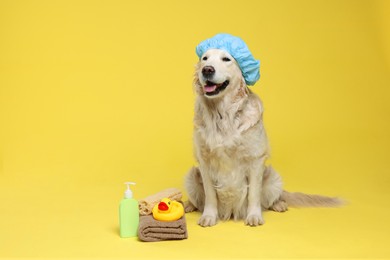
left=185, top=49, right=340, bottom=227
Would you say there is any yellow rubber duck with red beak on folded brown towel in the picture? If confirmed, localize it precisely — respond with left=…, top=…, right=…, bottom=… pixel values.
left=152, top=198, right=184, bottom=221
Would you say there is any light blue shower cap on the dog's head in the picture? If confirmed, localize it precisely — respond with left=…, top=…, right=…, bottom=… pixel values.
left=196, top=33, right=260, bottom=85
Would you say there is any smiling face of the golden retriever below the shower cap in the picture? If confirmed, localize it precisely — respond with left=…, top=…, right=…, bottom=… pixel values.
left=195, top=49, right=245, bottom=98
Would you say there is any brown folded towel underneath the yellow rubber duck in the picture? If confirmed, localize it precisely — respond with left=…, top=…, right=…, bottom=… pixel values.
left=138, top=215, right=188, bottom=242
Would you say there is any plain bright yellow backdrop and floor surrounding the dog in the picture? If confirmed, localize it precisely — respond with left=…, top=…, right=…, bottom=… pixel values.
left=0, top=0, right=390, bottom=259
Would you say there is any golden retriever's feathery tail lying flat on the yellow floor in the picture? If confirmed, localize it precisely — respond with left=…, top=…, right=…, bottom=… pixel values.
left=281, top=191, right=345, bottom=208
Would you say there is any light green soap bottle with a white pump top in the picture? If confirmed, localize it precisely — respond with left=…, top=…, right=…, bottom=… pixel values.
left=119, top=182, right=139, bottom=237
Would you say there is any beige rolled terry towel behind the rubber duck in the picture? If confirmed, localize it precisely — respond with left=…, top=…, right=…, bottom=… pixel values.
left=138, top=188, right=183, bottom=216
